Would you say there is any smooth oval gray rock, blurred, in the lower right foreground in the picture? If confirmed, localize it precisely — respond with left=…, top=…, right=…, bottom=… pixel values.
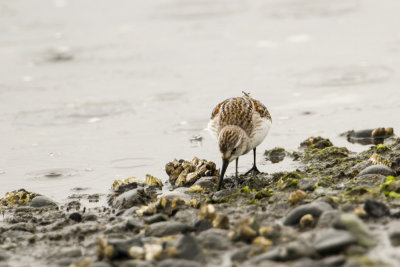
left=312, top=229, right=357, bottom=254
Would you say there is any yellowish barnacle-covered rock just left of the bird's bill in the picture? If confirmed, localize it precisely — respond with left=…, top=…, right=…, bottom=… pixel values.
left=165, top=157, right=219, bottom=186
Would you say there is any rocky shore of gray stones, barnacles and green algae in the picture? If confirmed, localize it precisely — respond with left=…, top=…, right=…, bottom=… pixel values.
left=0, top=137, right=400, bottom=267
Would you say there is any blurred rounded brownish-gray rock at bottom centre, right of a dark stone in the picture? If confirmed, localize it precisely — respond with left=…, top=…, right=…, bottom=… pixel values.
left=197, top=228, right=230, bottom=250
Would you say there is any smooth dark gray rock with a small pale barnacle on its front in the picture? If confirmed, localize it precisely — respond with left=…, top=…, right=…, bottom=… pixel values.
left=283, top=201, right=332, bottom=225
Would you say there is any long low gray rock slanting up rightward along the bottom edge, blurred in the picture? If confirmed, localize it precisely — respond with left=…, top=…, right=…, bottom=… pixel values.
left=249, top=241, right=315, bottom=265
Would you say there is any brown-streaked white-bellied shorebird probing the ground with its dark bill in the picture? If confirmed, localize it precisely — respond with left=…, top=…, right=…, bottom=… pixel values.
left=207, top=92, right=272, bottom=191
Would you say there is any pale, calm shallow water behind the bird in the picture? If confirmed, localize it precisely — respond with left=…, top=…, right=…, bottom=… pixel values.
left=0, top=0, right=400, bottom=201
